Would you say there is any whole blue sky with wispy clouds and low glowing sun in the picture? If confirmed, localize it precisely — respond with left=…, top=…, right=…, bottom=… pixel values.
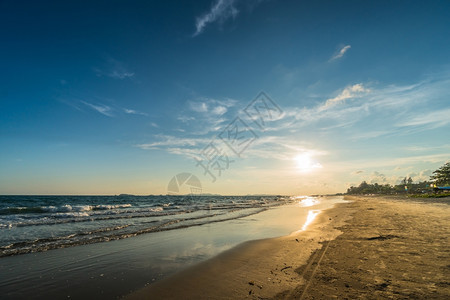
left=0, top=0, right=450, bottom=195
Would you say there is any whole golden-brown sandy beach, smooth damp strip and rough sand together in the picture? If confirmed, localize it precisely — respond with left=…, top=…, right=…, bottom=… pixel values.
left=128, top=197, right=450, bottom=299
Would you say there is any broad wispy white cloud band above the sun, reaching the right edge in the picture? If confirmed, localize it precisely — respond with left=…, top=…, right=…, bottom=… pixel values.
left=269, top=76, right=450, bottom=135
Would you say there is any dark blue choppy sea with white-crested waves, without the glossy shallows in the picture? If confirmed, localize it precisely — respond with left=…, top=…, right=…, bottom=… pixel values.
left=0, top=195, right=293, bottom=257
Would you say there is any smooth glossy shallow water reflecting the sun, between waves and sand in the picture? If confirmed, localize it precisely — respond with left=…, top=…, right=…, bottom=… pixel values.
left=0, top=197, right=344, bottom=299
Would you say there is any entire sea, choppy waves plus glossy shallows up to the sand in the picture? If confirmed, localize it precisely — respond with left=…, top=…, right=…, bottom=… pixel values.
left=0, top=195, right=345, bottom=299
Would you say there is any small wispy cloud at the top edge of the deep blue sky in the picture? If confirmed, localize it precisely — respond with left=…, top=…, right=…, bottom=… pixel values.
left=193, top=0, right=239, bottom=37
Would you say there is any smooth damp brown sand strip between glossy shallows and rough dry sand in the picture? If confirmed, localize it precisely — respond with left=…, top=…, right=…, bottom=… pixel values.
left=125, top=198, right=353, bottom=299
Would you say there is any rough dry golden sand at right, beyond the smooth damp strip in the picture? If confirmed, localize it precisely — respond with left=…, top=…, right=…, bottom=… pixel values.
left=282, top=196, right=450, bottom=299
